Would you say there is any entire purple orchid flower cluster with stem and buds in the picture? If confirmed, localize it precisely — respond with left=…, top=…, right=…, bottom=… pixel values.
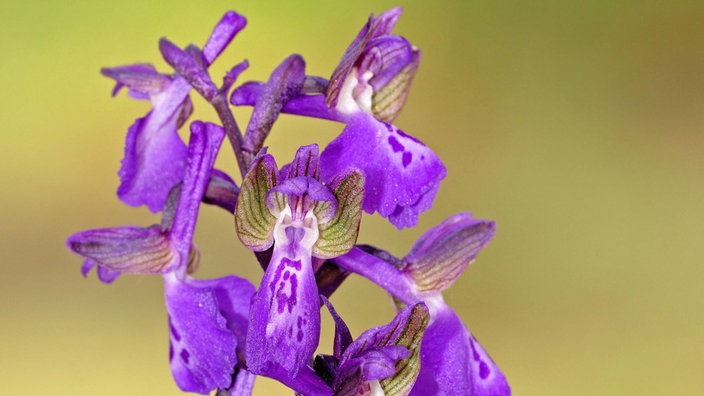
left=67, top=8, right=510, bottom=395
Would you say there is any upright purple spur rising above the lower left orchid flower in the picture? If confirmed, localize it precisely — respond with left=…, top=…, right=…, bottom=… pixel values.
left=171, top=121, right=225, bottom=256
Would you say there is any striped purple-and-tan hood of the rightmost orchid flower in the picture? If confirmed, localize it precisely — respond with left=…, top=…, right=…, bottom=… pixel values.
left=403, top=213, right=496, bottom=294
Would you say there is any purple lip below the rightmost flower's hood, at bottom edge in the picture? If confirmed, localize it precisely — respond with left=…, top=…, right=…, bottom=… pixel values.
left=411, top=303, right=511, bottom=396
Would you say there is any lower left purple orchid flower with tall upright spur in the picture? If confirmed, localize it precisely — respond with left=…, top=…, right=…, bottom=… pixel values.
left=67, top=122, right=255, bottom=394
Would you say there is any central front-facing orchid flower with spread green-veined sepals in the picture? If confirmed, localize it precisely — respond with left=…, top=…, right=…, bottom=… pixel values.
left=235, top=145, right=364, bottom=383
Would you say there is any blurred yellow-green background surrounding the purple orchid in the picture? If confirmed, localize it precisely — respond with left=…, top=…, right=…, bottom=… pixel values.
left=0, top=0, right=704, bottom=395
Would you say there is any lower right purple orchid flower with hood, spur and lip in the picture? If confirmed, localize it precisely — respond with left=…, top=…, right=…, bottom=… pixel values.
left=333, top=213, right=511, bottom=396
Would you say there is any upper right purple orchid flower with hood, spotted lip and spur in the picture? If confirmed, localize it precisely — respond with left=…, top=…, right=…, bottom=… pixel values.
left=231, top=8, right=446, bottom=228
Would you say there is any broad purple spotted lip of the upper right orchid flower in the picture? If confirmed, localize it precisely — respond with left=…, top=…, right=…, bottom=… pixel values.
left=320, top=114, right=446, bottom=228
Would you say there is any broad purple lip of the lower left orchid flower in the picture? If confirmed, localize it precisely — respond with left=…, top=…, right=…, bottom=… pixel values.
left=164, top=274, right=254, bottom=394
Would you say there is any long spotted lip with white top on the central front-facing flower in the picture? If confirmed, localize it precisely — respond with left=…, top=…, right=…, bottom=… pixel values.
left=246, top=208, right=320, bottom=383
